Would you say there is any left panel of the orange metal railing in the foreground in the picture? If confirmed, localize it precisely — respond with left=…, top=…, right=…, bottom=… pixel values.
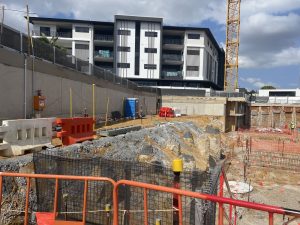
left=0, top=173, right=115, bottom=225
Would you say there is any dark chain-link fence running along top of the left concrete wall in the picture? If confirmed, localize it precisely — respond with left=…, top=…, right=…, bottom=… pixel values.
left=0, top=25, right=158, bottom=94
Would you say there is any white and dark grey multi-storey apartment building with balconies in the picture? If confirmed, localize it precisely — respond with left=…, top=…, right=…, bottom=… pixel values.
left=30, top=15, right=224, bottom=89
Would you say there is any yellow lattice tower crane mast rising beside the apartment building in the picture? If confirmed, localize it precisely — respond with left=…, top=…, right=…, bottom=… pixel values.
left=224, top=0, right=241, bottom=91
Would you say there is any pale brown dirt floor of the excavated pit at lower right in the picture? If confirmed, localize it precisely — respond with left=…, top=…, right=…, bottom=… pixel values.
left=227, top=141, right=300, bottom=225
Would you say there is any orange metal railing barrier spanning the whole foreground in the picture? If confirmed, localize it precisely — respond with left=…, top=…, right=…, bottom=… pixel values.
left=0, top=172, right=300, bottom=225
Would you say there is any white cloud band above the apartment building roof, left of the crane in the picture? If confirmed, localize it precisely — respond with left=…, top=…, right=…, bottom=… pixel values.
left=0, top=0, right=226, bottom=25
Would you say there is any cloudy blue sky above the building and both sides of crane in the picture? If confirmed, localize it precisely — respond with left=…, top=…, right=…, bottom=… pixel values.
left=0, top=0, right=300, bottom=90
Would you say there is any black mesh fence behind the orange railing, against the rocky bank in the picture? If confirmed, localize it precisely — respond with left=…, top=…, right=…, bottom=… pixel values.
left=33, top=150, right=221, bottom=225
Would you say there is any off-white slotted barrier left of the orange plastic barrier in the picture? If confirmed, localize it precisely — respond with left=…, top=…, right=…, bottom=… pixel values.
left=0, top=118, right=55, bottom=156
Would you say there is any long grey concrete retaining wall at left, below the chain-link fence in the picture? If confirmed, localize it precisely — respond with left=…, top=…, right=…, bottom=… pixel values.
left=0, top=48, right=156, bottom=121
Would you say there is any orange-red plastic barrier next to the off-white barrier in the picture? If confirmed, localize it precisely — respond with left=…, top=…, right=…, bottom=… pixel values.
left=56, top=117, right=95, bottom=145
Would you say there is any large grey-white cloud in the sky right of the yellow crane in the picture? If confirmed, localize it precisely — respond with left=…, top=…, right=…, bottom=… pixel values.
left=239, top=5, right=300, bottom=68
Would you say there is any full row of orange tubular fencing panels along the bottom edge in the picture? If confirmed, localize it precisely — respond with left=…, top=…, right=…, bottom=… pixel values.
left=0, top=172, right=300, bottom=225
